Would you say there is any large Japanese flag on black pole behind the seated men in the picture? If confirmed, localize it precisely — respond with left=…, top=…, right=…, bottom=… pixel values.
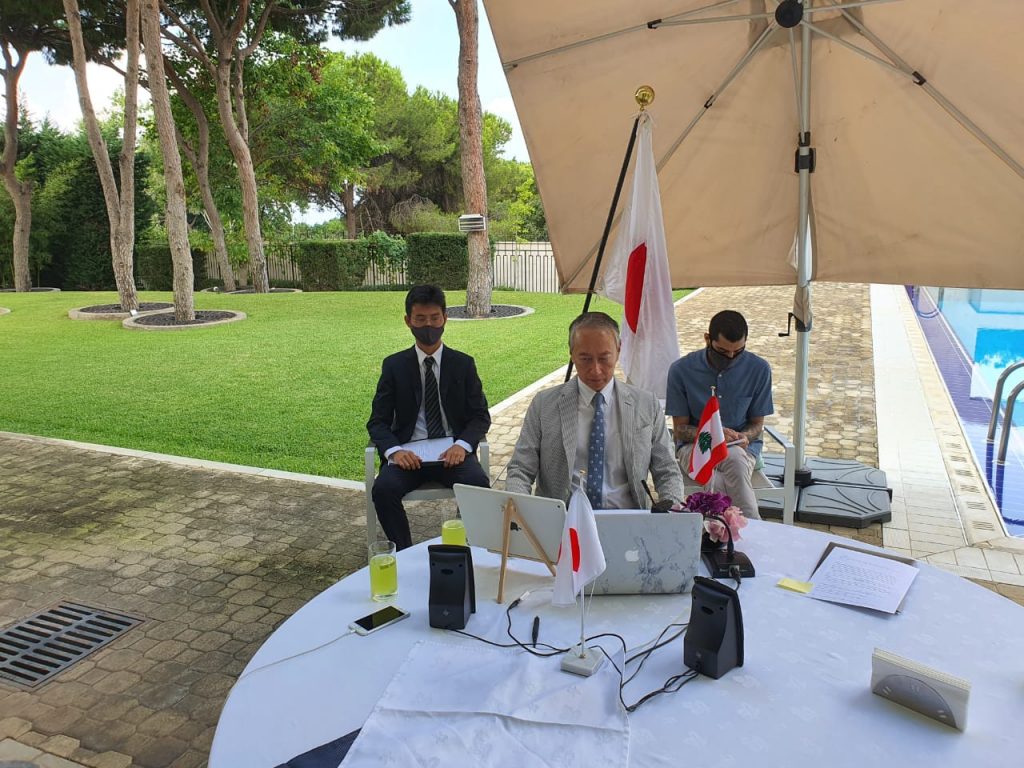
left=600, top=113, right=679, bottom=400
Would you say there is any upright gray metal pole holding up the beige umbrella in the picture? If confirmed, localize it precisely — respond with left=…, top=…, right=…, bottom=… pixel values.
left=793, top=25, right=814, bottom=475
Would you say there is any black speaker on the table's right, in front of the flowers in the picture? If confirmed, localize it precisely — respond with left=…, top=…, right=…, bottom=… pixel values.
left=683, top=577, right=743, bottom=680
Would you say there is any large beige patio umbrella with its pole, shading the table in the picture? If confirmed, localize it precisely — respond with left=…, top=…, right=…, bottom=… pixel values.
left=484, top=0, right=1024, bottom=463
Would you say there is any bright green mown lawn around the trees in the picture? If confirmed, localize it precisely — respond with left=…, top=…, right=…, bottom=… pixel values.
left=0, top=291, right=681, bottom=479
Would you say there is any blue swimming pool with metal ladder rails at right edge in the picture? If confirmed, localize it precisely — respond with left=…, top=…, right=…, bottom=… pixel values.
left=907, top=287, right=1024, bottom=536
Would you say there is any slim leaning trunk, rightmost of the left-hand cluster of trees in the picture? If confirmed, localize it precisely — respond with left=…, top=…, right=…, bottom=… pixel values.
left=216, top=50, right=270, bottom=293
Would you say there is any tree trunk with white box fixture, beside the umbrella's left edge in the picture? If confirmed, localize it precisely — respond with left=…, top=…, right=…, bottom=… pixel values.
left=449, top=0, right=492, bottom=317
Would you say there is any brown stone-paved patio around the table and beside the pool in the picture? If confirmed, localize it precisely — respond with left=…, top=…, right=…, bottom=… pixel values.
left=0, top=285, right=1024, bottom=768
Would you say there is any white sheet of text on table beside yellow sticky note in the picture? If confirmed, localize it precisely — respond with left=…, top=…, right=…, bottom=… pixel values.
left=808, top=547, right=918, bottom=613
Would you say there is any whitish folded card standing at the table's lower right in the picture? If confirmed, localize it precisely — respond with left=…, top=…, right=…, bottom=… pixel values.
left=871, top=648, right=971, bottom=730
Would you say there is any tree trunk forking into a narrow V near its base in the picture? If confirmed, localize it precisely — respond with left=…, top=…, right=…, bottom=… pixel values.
left=63, top=0, right=139, bottom=312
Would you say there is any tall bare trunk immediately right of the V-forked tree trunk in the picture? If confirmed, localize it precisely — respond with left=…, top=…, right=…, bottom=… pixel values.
left=142, top=0, right=196, bottom=323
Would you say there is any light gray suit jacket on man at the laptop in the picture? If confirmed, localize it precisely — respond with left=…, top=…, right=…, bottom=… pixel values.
left=505, top=378, right=684, bottom=509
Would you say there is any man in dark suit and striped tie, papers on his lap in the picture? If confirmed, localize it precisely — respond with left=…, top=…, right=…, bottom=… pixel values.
left=367, top=286, right=490, bottom=549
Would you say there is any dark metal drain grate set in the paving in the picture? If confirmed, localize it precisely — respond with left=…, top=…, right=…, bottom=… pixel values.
left=0, top=603, right=142, bottom=688
